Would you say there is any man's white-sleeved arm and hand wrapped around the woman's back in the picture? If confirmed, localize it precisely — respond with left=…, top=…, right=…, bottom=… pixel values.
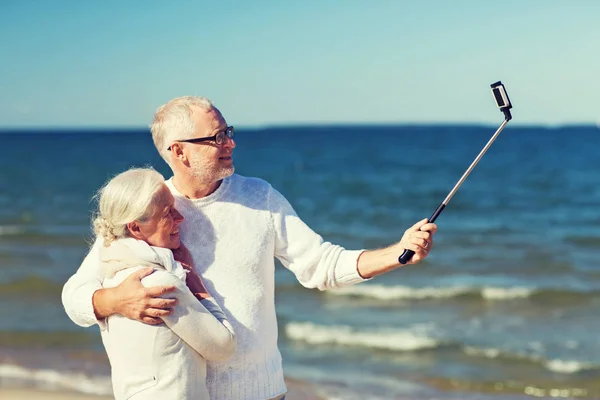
left=62, top=240, right=176, bottom=327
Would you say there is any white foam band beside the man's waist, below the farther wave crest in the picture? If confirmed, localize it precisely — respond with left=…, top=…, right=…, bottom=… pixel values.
left=285, top=322, right=441, bottom=351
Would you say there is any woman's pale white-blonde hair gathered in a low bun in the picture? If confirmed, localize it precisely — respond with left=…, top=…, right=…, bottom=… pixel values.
left=93, top=168, right=165, bottom=246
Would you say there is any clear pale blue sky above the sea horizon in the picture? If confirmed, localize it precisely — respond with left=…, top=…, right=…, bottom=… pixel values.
left=0, top=0, right=600, bottom=127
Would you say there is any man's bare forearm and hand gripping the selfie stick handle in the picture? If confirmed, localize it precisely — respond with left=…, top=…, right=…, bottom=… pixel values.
left=357, top=219, right=437, bottom=279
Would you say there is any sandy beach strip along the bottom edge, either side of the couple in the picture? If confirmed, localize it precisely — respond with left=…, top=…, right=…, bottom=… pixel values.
left=0, top=378, right=325, bottom=400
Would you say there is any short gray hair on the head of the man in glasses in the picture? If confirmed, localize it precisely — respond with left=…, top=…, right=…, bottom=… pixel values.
left=150, top=96, right=214, bottom=165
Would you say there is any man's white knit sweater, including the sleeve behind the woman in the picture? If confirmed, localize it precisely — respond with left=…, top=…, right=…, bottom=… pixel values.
left=63, top=175, right=363, bottom=400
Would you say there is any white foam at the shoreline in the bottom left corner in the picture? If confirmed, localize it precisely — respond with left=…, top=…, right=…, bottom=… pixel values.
left=0, top=364, right=112, bottom=395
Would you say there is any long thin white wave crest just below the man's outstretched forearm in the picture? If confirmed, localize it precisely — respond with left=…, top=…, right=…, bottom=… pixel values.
left=325, top=284, right=535, bottom=300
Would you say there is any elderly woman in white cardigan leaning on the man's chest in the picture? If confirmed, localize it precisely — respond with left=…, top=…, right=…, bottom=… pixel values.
left=93, top=168, right=235, bottom=400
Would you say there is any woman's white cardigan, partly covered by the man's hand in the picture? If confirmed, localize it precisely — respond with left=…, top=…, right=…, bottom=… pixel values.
left=99, top=239, right=235, bottom=400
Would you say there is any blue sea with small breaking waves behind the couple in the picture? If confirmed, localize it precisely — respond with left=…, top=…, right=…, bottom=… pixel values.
left=0, top=122, right=600, bottom=400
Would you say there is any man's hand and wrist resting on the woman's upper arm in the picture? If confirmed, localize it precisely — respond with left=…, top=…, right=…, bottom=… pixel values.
left=92, top=267, right=177, bottom=325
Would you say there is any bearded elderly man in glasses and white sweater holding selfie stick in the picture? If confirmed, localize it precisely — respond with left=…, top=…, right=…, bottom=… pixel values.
left=63, top=97, right=437, bottom=400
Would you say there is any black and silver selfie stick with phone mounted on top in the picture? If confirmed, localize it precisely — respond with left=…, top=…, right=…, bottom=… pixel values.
left=398, top=81, right=512, bottom=264
